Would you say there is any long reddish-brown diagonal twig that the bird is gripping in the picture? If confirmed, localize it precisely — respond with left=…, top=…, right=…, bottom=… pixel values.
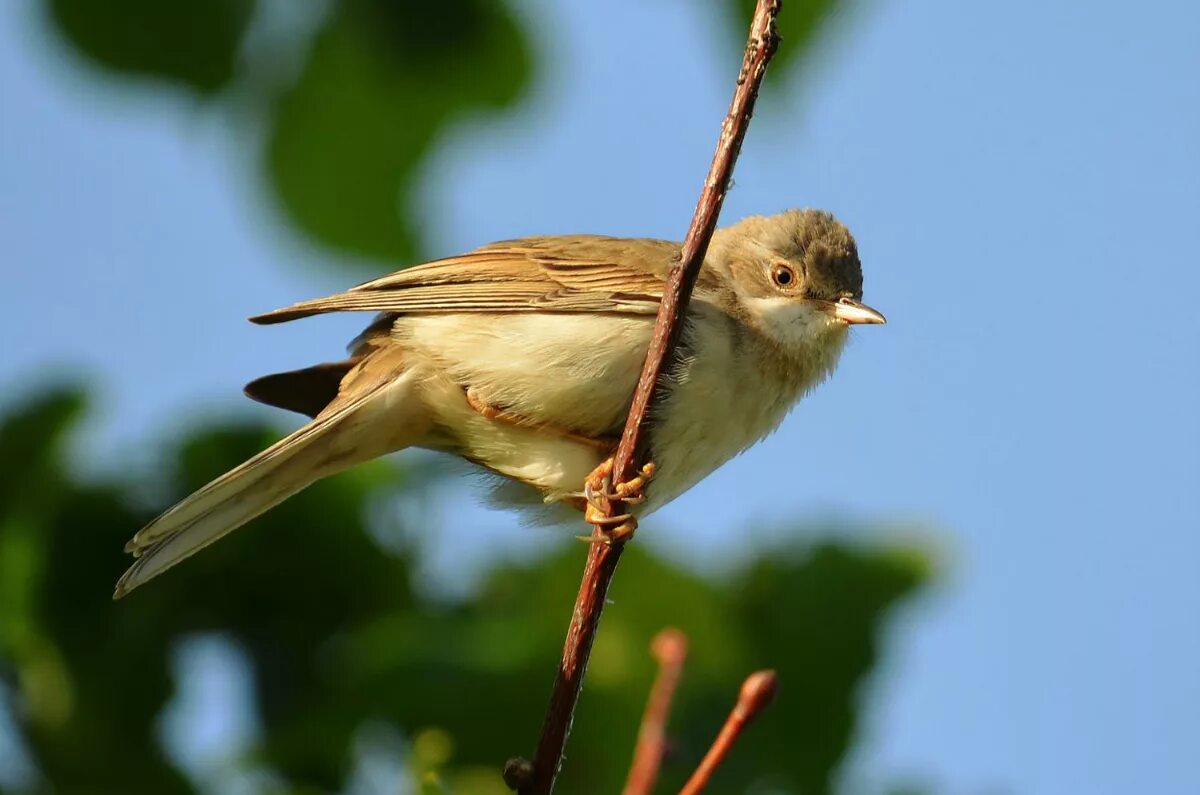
left=520, top=0, right=781, bottom=795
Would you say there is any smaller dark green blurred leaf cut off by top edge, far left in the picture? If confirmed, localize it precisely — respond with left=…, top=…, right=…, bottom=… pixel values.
left=47, top=0, right=256, bottom=94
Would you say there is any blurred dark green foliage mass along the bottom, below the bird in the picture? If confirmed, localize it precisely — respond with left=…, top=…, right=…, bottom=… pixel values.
left=0, top=390, right=924, bottom=794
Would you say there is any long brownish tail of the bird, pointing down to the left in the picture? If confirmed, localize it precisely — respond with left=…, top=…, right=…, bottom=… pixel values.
left=113, top=357, right=420, bottom=599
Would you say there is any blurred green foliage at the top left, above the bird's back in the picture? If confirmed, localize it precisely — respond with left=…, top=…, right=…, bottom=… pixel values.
left=43, top=0, right=533, bottom=268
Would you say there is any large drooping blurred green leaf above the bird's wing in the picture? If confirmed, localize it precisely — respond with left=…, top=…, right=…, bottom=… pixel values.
left=266, top=0, right=530, bottom=264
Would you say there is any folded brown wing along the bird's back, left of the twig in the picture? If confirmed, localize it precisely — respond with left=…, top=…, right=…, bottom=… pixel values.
left=250, top=235, right=679, bottom=323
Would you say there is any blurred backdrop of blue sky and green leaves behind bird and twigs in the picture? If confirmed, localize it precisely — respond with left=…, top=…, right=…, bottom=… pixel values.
left=0, top=0, right=1200, bottom=795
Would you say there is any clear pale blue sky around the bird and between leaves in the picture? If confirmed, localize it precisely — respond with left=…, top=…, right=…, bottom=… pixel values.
left=0, top=0, right=1200, bottom=795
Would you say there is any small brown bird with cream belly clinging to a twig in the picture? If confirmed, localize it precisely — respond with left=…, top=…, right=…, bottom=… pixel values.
left=115, top=210, right=884, bottom=597
